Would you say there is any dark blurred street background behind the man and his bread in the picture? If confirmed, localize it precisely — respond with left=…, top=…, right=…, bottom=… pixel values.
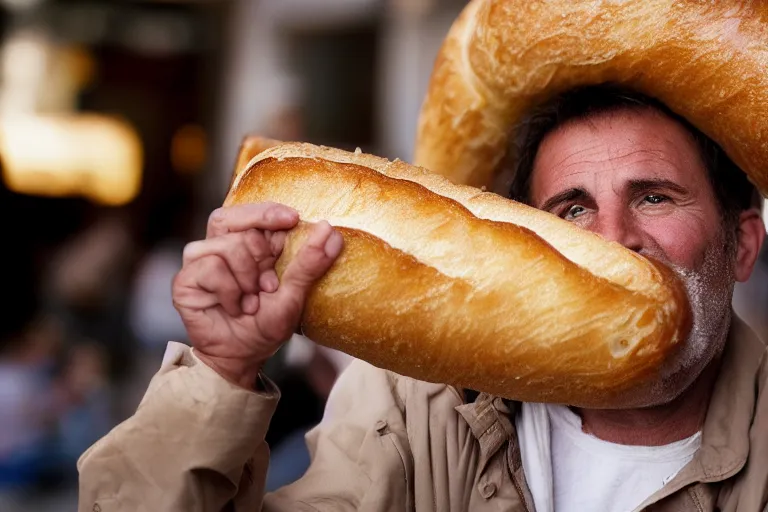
left=0, top=0, right=768, bottom=512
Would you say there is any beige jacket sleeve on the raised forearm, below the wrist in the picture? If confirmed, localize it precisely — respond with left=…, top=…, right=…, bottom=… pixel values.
left=78, top=343, right=279, bottom=512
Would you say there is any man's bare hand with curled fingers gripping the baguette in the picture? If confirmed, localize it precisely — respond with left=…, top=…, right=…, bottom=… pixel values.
left=173, top=203, right=343, bottom=389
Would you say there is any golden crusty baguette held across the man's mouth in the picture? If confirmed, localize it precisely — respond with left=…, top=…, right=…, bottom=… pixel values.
left=225, top=143, right=690, bottom=407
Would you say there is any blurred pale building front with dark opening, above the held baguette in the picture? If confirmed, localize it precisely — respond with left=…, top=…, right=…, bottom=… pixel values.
left=218, top=0, right=466, bottom=191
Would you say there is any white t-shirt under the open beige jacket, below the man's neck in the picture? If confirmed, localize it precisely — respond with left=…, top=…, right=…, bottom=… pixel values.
left=546, top=405, right=701, bottom=512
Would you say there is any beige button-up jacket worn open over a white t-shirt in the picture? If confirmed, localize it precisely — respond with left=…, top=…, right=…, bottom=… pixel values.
left=79, top=319, right=768, bottom=512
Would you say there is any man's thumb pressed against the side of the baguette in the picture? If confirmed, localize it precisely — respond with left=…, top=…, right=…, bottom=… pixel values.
left=277, top=221, right=344, bottom=307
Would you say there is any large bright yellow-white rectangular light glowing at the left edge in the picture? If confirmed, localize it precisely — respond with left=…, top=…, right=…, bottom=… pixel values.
left=0, top=115, right=143, bottom=206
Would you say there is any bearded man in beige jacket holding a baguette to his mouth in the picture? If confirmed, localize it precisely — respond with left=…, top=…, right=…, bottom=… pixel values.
left=80, top=87, right=768, bottom=512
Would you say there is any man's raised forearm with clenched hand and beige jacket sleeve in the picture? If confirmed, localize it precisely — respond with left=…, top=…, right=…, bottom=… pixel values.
left=79, top=203, right=344, bottom=512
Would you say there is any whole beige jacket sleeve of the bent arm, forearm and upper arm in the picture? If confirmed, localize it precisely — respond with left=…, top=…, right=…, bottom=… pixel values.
left=78, top=344, right=412, bottom=512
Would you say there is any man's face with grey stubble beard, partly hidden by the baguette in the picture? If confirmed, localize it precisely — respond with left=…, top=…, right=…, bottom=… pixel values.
left=530, top=110, right=735, bottom=405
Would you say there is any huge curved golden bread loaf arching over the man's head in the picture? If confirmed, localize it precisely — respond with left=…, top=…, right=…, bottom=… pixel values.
left=415, top=0, right=768, bottom=195
